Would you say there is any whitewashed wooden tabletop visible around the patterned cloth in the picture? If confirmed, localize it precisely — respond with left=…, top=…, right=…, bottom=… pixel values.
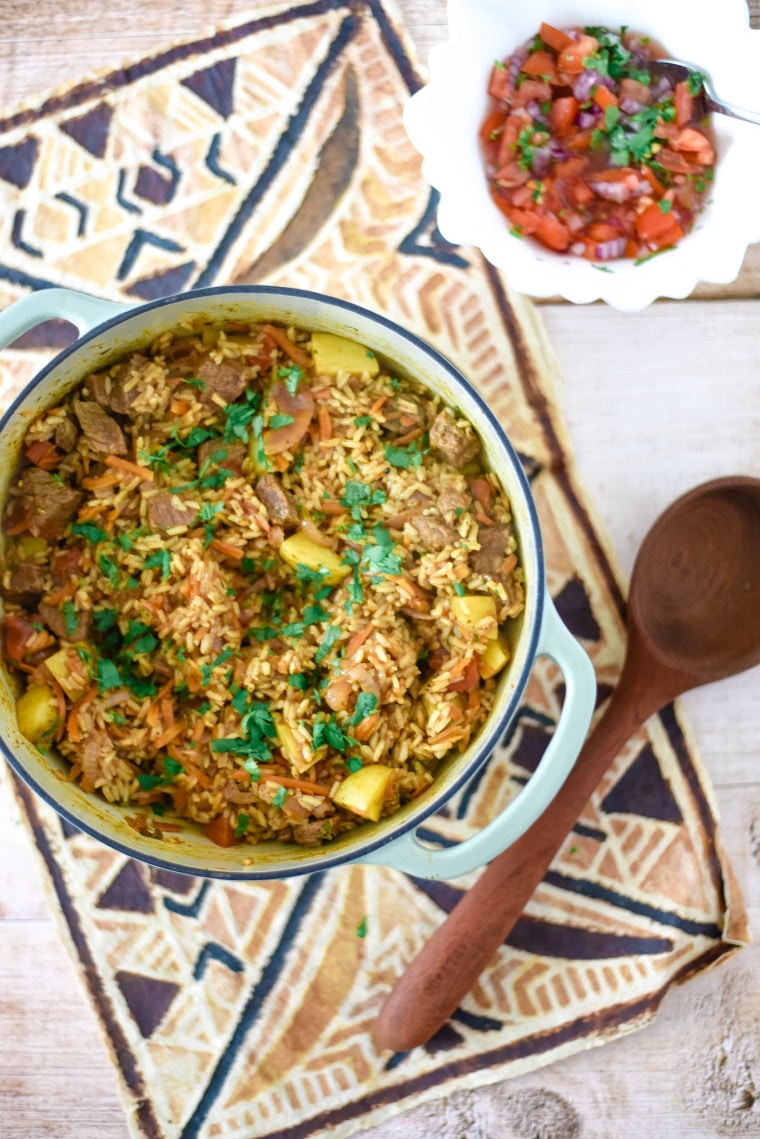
left=0, top=0, right=760, bottom=1139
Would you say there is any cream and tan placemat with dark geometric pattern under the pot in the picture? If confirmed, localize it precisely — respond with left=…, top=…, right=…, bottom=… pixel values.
left=0, top=0, right=746, bottom=1139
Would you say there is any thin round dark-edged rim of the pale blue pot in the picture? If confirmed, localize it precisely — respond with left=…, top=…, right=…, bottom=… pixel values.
left=0, top=285, right=546, bottom=882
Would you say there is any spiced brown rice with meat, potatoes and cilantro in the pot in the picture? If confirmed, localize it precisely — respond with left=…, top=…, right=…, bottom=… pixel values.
left=1, top=323, right=524, bottom=845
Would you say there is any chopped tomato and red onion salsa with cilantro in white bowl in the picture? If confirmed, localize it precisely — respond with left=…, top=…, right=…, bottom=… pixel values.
left=480, top=24, right=716, bottom=262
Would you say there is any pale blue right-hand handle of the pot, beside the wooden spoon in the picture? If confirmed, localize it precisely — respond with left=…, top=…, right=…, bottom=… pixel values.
left=357, top=595, right=596, bottom=878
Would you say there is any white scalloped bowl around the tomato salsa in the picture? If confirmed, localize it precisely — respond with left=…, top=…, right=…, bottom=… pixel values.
left=404, top=0, right=760, bottom=312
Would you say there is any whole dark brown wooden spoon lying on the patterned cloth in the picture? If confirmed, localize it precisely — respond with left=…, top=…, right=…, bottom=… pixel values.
left=375, top=476, right=760, bottom=1051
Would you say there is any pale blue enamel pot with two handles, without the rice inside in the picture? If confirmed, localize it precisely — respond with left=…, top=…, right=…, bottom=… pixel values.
left=0, top=286, right=596, bottom=879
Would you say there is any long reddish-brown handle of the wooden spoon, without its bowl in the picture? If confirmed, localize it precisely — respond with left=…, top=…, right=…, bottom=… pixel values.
left=375, top=680, right=660, bottom=1051
